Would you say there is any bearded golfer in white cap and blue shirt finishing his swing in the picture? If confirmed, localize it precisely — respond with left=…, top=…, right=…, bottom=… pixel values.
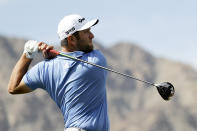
left=8, top=14, right=109, bottom=131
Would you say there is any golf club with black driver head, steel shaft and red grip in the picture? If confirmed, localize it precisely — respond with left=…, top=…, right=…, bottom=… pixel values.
left=49, top=50, right=175, bottom=100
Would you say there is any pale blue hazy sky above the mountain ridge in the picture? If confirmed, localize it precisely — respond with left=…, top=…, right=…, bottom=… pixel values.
left=0, top=0, right=197, bottom=69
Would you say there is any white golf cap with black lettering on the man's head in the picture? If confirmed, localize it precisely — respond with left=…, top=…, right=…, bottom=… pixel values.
left=57, top=14, right=99, bottom=40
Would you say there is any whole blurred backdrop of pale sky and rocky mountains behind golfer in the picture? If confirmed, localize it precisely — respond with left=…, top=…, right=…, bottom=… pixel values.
left=0, top=0, right=197, bottom=131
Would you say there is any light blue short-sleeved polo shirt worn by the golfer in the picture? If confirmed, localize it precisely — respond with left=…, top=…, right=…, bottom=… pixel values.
left=23, top=50, right=109, bottom=131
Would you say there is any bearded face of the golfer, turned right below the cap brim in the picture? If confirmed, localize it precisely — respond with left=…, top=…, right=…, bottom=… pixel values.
left=77, top=28, right=94, bottom=53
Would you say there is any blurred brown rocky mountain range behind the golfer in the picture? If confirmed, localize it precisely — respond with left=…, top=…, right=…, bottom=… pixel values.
left=0, top=36, right=197, bottom=131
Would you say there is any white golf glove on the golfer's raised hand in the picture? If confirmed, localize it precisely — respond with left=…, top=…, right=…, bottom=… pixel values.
left=23, top=40, right=38, bottom=59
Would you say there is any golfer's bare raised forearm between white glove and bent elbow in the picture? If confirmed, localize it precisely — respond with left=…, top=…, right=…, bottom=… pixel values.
left=8, top=54, right=32, bottom=93
